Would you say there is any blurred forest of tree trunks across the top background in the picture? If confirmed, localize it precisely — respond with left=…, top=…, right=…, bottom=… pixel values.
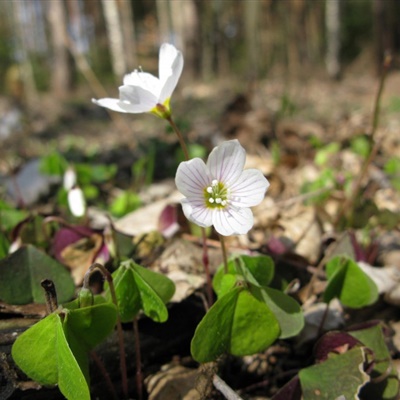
left=0, top=0, right=400, bottom=105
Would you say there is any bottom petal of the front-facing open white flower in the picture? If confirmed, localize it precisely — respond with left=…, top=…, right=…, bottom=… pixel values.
left=213, top=207, right=254, bottom=236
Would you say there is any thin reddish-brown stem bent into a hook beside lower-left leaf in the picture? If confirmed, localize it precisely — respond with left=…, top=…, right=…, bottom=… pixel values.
left=83, top=263, right=129, bottom=399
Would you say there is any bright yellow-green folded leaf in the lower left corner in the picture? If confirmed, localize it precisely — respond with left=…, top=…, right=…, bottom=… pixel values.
left=11, top=313, right=90, bottom=400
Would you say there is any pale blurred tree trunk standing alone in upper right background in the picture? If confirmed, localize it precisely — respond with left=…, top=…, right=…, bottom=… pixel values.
left=325, top=0, right=340, bottom=79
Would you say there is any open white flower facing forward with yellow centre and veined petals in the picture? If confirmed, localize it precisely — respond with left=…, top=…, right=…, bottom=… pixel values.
left=175, top=140, right=269, bottom=236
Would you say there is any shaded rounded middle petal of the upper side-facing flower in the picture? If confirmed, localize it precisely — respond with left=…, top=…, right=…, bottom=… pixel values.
left=119, top=85, right=157, bottom=113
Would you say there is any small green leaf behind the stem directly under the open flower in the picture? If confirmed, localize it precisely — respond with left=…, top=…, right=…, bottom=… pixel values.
left=213, top=255, right=275, bottom=296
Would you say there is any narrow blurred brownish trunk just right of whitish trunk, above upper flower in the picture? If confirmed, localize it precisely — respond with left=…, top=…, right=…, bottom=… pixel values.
left=118, top=0, right=137, bottom=72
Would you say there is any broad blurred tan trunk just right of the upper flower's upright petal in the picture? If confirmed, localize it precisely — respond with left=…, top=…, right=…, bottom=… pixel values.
left=170, top=0, right=200, bottom=78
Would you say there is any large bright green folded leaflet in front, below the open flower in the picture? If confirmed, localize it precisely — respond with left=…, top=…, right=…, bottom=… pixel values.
left=191, top=287, right=280, bottom=362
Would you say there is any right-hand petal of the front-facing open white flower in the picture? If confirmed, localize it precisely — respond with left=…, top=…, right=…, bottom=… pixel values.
left=229, top=169, right=269, bottom=207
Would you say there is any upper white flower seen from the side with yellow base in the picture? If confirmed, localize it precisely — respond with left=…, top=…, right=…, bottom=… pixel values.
left=92, top=43, right=183, bottom=118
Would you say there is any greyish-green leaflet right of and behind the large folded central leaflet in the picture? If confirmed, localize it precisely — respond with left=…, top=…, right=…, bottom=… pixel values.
left=250, top=286, right=304, bottom=339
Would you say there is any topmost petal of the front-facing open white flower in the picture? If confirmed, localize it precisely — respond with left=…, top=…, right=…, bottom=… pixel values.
left=207, top=139, right=246, bottom=186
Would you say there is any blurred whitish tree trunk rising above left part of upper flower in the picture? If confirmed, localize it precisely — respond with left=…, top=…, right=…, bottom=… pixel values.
left=102, top=0, right=127, bottom=80
